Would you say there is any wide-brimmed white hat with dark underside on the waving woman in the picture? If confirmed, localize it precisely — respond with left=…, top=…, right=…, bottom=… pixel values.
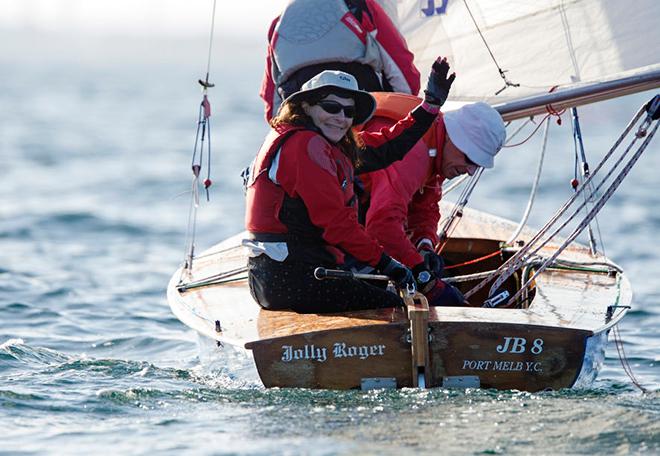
left=282, top=70, right=376, bottom=125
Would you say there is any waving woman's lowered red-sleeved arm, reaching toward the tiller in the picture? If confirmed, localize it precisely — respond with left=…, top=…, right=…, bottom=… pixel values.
left=277, top=131, right=383, bottom=266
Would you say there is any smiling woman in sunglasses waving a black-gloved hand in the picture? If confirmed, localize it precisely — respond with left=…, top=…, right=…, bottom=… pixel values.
left=244, top=59, right=455, bottom=313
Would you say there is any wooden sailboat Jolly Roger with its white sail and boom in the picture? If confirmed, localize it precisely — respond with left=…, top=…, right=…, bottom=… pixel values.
left=168, top=0, right=660, bottom=391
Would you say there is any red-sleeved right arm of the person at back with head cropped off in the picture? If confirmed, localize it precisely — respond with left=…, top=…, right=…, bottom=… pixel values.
left=363, top=0, right=420, bottom=95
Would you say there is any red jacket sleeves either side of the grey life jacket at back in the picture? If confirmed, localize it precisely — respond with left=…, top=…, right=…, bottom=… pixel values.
left=259, top=0, right=420, bottom=121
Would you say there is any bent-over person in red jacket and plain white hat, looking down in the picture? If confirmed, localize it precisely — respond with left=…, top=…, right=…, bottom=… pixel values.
left=360, top=94, right=506, bottom=306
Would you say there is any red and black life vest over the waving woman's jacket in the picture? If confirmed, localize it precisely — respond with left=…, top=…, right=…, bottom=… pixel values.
left=245, top=126, right=357, bottom=265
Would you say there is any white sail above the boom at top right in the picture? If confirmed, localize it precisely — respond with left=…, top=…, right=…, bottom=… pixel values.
left=390, top=0, right=660, bottom=105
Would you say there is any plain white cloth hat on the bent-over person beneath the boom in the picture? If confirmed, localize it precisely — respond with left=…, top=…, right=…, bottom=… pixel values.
left=444, top=102, right=506, bottom=168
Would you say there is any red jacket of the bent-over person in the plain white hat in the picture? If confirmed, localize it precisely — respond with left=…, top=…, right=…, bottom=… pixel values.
left=360, top=98, right=445, bottom=267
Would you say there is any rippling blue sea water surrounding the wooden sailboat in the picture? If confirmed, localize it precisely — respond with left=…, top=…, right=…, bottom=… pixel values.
left=0, top=33, right=660, bottom=455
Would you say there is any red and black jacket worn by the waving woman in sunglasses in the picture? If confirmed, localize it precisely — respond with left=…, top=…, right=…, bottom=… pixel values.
left=246, top=108, right=435, bottom=266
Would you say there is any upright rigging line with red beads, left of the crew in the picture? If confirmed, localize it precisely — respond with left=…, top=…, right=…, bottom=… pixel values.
left=179, top=0, right=217, bottom=282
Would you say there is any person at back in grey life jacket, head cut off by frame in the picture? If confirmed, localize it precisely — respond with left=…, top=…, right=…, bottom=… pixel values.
left=260, top=0, right=420, bottom=121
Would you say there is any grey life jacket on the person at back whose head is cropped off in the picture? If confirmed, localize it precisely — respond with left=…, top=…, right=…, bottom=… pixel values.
left=270, top=0, right=383, bottom=87
